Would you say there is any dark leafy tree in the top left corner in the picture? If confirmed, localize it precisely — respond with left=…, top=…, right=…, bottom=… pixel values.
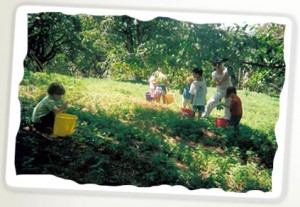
left=24, top=12, right=80, bottom=73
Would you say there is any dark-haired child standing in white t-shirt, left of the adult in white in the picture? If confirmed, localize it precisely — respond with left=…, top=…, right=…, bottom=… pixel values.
left=189, top=68, right=207, bottom=118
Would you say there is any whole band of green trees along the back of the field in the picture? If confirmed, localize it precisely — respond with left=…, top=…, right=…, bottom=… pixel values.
left=24, top=12, right=286, bottom=94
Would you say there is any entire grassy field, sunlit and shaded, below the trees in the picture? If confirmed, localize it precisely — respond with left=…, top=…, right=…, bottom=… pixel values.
left=16, top=71, right=279, bottom=192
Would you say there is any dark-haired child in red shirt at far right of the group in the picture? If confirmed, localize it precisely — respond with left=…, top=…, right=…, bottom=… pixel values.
left=226, top=86, right=243, bottom=129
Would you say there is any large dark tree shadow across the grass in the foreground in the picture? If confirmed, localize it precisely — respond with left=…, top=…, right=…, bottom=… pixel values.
left=15, top=100, right=276, bottom=191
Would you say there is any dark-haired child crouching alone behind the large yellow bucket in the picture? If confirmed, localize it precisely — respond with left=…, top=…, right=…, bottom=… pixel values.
left=32, top=83, right=67, bottom=133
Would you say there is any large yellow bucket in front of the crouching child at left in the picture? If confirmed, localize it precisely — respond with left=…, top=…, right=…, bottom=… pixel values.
left=53, top=113, right=78, bottom=137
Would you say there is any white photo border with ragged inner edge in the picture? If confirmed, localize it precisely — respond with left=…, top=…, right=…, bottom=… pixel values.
left=6, top=5, right=292, bottom=200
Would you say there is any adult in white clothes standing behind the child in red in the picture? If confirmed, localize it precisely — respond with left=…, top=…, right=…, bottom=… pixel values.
left=204, top=60, right=232, bottom=120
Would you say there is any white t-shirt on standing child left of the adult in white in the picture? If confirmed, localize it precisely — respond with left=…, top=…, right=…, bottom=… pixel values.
left=189, top=80, right=207, bottom=106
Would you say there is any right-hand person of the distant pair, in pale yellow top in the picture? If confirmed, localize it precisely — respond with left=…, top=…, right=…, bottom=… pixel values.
left=154, top=68, right=170, bottom=104
